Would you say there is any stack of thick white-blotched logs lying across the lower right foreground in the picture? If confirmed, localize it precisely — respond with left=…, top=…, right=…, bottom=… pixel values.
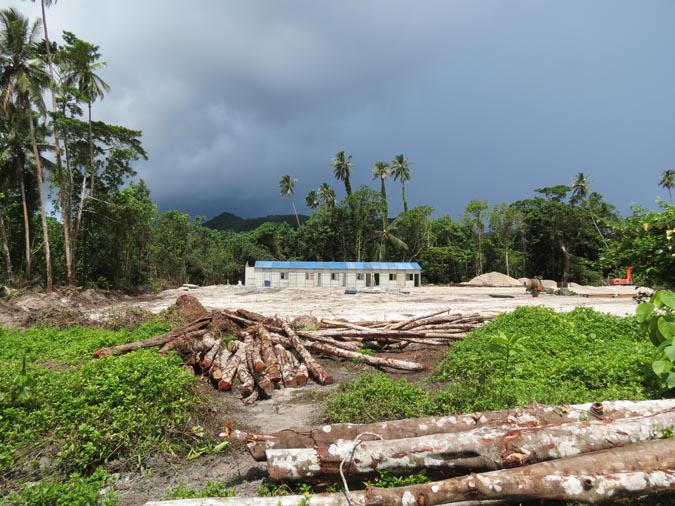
left=147, top=399, right=675, bottom=506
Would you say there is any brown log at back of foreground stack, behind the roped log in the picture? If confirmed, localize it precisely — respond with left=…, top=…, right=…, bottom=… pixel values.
left=230, top=399, right=675, bottom=461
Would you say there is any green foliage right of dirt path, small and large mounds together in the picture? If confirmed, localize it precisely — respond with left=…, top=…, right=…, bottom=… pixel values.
left=327, top=307, right=661, bottom=422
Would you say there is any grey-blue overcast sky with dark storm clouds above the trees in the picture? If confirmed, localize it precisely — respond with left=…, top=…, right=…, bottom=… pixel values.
left=11, top=0, right=675, bottom=218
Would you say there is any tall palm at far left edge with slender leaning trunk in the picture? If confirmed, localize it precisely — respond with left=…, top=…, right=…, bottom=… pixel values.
left=0, top=9, right=53, bottom=292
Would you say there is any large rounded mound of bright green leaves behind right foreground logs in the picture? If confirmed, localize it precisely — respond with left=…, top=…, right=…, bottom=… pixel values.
left=436, top=307, right=658, bottom=412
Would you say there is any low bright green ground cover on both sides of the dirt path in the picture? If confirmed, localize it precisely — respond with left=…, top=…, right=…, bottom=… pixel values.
left=0, top=307, right=662, bottom=505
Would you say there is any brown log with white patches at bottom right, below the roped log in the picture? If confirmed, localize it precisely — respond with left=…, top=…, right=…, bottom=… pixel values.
left=366, top=439, right=675, bottom=506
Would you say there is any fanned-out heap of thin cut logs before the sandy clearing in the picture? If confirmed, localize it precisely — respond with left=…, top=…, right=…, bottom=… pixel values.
left=95, top=300, right=487, bottom=404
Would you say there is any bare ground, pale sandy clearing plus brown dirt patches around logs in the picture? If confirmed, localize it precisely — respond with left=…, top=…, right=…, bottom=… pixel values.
left=0, top=285, right=649, bottom=506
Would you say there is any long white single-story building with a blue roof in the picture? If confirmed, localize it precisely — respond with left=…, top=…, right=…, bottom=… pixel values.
left=245, top=260, right=422, bottom=289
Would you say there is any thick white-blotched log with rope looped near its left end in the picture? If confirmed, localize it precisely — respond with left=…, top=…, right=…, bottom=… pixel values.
left=265, top=409, right=675, bottom=480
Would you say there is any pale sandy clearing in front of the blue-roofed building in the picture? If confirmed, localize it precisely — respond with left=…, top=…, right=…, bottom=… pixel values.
left=133, top=285, right=647, bottom=321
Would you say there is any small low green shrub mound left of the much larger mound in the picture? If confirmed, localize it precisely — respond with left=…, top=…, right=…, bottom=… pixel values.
left=326, top=373, right=436, bottom=423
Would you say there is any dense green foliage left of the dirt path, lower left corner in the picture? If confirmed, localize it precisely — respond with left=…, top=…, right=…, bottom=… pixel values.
left=0, top=321, right=198, bottom=504
